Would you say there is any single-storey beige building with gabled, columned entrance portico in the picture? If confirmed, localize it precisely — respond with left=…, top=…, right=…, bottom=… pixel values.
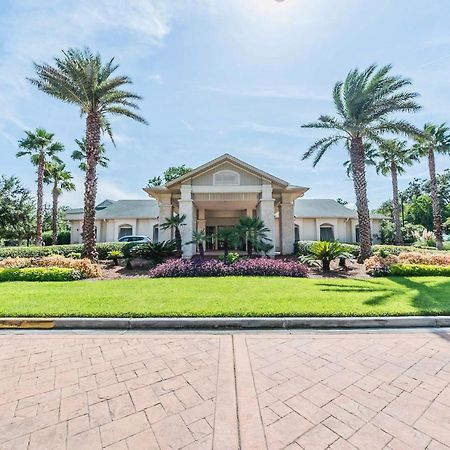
left=67, top=154, right=385, bottom=253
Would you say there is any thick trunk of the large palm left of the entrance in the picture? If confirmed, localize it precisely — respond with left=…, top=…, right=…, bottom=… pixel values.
left=83, top=112, right=100, bottom=261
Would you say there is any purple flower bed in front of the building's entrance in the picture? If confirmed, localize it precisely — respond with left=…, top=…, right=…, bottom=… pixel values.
left=149, top=258, right=308, bottom=278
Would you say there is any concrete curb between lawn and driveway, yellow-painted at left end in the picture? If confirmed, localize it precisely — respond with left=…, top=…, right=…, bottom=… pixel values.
left=0, top=316, right=450, bottom=330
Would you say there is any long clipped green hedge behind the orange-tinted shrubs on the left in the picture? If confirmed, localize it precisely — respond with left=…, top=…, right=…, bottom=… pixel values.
left=0, top=242, right=125, bottom=259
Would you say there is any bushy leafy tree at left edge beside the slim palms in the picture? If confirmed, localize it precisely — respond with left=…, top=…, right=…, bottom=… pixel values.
left=0, top=175, right=36, bottom=244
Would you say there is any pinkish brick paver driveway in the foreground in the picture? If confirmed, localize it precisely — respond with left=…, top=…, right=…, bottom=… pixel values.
left=0, top=331, right=450, bottom=450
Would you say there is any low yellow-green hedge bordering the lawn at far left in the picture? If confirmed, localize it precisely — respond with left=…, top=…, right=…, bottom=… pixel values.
left=0, top=267, right=82, bottom=282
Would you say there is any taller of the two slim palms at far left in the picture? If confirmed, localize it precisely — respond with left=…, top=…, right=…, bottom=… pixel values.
left=17, top=128, right=64, bottom=245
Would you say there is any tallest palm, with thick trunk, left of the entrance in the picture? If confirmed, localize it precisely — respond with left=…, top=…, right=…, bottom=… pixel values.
left=30, top=48, right=147, bottom=260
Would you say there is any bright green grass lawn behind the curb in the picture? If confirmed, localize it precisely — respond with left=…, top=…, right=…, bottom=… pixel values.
left=0, top=277, right=450, bottom=317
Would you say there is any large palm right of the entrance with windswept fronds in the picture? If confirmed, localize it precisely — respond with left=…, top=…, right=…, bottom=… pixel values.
left=302, top=65, right=420, bottom=262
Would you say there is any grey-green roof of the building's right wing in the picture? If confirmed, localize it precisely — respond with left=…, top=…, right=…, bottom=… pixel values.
left=294, top=198, right=386, bottom=219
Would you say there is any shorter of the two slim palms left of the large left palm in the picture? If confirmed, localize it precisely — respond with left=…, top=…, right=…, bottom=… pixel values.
left=44, top=159, right=75, bottom=245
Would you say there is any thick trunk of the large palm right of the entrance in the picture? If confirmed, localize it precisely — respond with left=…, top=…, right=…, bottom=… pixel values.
left=350, top=137, right=372, bottom=263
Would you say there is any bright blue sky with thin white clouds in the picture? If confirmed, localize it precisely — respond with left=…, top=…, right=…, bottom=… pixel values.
left=0, top=0, right=450, bottom=208
